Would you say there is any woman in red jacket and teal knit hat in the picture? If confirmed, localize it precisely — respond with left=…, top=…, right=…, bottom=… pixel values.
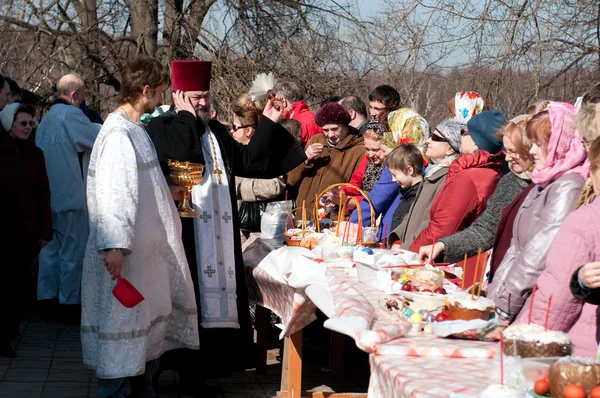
left=409, top=110, right=506, bottom=252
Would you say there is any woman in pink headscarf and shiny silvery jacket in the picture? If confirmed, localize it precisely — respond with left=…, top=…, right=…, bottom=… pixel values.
left=487, top=102, right=588, bottom=322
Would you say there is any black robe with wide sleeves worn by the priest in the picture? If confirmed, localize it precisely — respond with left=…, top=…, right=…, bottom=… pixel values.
left=146, top=110, right=306, bottom=377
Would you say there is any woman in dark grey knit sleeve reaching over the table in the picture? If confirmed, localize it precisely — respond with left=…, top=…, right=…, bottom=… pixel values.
left=419, top=115, right=533, bottom=262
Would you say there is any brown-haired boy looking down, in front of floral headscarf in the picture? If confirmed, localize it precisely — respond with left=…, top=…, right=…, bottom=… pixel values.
left=385, top=144, right=423, bottom=230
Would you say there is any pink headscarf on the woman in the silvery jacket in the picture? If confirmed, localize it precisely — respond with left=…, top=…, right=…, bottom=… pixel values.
left=531, top=101, right=589, bottom=188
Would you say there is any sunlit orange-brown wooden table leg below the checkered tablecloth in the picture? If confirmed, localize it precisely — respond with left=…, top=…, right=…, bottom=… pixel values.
left=281, top=330, right=302, bottom=398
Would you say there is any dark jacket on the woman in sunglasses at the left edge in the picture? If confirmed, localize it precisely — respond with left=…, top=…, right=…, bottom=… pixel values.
left=0, top=133, right=53, bottom=254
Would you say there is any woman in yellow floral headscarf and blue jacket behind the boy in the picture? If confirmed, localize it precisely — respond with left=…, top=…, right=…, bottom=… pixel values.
left=350, top=108, right=429, bottom=239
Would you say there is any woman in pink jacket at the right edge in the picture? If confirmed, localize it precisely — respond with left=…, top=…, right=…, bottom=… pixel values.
left=515, top=140, right=600, bottom=357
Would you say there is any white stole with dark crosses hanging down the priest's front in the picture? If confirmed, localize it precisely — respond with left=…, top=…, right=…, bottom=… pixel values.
left=192, top=126, right=240, bottom=329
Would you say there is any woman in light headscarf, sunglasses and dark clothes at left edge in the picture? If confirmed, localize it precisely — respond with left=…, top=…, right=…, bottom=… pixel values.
left=0, top=103, right=52, bottom=358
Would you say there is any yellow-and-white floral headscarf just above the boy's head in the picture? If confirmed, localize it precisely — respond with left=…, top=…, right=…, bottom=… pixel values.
left=381, top=108, right=429, bottom=153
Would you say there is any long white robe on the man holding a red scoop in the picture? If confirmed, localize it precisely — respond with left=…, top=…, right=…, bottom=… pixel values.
left=81, top=112, right=199, bottom=379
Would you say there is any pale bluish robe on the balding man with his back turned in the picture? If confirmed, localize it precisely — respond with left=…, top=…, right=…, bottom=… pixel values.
left=35, top=104, right=102, bottom=304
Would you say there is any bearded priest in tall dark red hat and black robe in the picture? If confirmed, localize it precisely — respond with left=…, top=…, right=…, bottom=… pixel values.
left=147, top=60, right=306, bottom=384
